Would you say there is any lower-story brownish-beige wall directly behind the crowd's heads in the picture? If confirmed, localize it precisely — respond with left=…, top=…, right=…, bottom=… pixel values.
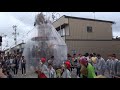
left=66, top=41, right=120, bottom=59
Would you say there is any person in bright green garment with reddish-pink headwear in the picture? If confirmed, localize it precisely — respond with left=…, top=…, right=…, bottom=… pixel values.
left=80, top=58, right=96, bottom=78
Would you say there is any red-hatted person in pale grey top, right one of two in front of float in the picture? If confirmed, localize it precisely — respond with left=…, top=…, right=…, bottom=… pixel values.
left=62, top=60, right=71, bottom=78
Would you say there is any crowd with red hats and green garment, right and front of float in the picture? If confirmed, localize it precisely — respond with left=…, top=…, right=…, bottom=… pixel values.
left=37, top=53, right=120, bottom=78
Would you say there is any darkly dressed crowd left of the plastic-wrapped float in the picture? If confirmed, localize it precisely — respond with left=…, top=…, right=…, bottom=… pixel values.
left=0, top=55, right=26, bottom=78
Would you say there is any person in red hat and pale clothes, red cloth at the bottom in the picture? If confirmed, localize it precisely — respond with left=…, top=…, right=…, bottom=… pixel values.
left=38, top=58, right=49, bottom=78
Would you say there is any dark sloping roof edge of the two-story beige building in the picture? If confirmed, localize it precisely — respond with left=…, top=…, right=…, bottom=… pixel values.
left=53, top=15, right=115, bottom=24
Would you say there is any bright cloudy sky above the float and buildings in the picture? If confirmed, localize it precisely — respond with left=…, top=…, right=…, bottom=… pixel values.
left=0, top=12, right=120, bottom=49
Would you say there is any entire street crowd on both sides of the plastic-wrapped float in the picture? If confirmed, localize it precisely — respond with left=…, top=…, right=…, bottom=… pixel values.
left=0, top=53, right=120, bottom=78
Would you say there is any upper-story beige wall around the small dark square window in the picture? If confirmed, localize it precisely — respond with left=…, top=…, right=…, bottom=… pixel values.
left=66, top=18, right=112, bottom=40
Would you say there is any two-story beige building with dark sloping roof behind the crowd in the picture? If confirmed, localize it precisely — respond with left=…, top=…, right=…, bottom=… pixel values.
left=53, top=15, right=120, bottom=58
